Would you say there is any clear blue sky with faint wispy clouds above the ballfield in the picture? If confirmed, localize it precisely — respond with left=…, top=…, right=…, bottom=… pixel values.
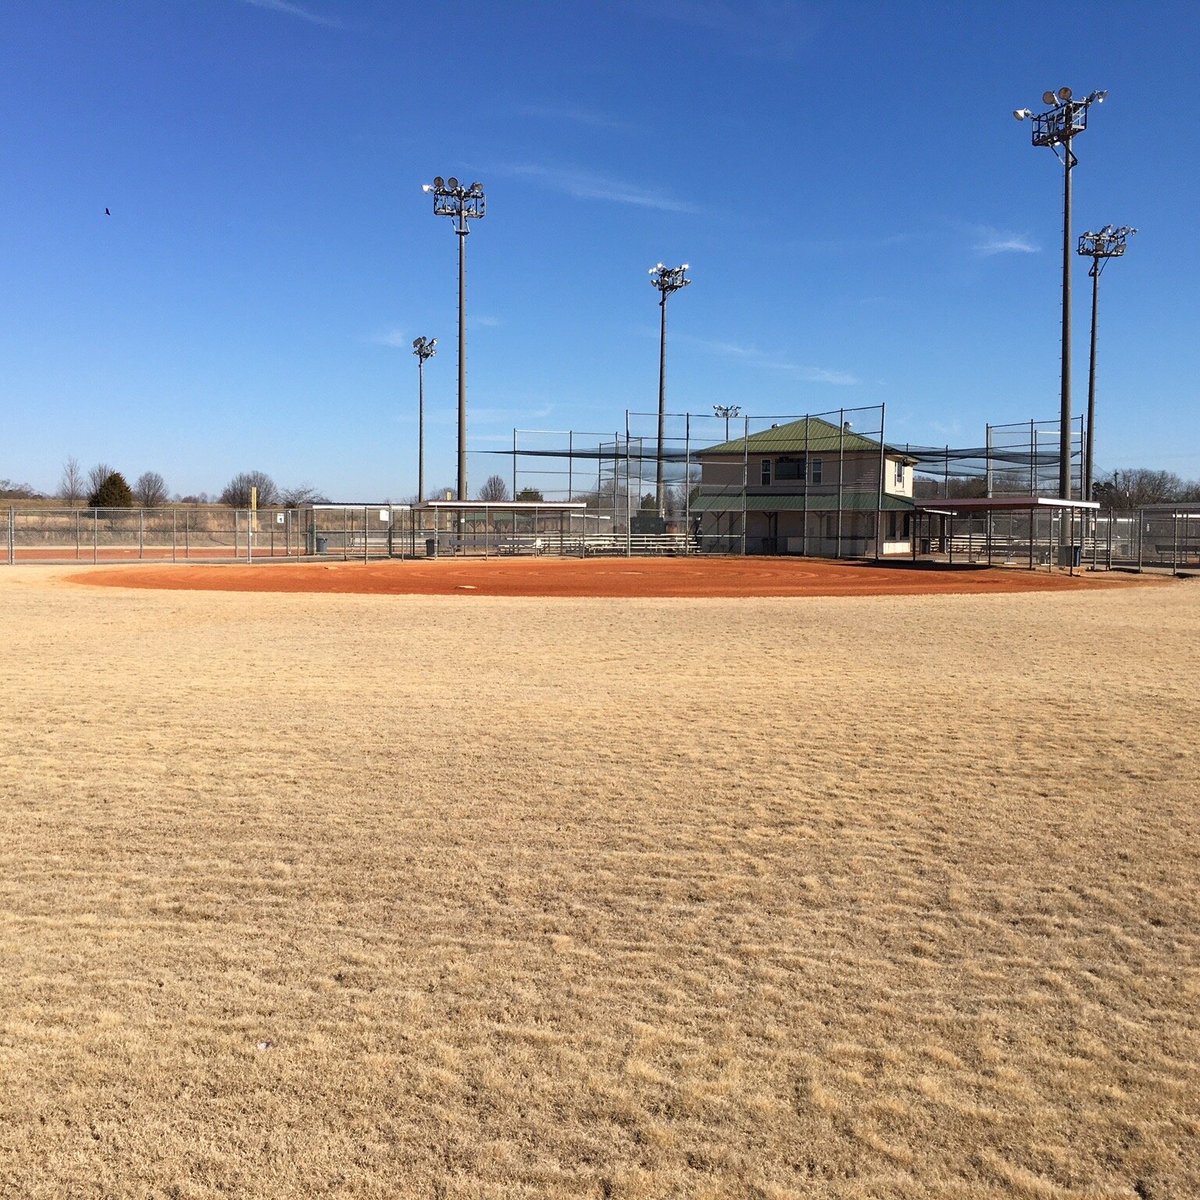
left=0, top=0, right=1200, bottom=499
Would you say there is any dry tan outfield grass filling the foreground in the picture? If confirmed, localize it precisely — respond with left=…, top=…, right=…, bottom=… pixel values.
left=0, top=568, right=1200, bottom=1200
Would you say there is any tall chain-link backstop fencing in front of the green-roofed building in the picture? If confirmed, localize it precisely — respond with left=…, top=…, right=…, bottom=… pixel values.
left=494, top=406, right=916, bottom=558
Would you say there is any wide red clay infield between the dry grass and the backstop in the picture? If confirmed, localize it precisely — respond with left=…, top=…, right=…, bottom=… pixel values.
left=71, top=557, right=1146, bottom=598
